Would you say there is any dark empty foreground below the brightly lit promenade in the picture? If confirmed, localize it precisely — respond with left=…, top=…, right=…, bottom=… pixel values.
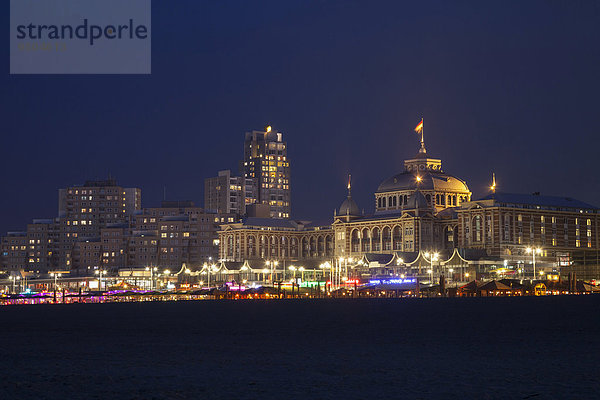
left=0, top=296, right=600, bottom=399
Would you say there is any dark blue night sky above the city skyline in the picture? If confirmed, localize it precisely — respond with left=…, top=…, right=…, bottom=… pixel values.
left=0, top=0, right=600, bottom=232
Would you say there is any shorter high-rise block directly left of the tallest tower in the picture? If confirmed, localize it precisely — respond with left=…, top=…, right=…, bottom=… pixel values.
left=204, top=170, right=245, bottom=215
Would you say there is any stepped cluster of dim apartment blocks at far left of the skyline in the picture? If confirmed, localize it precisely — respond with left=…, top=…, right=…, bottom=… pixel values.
left=0, top=180, right=236, bottom=274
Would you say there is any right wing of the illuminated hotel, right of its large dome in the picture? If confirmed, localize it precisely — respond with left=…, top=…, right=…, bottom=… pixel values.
left=457, top=193, right=600, bottom=279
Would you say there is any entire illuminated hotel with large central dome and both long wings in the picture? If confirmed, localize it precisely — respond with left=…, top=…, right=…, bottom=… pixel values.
left=219, top=136, right=600, bottom=279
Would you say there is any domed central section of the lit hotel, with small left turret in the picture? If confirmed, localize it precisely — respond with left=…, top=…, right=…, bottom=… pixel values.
left=332, top=137, right=471, bottom=258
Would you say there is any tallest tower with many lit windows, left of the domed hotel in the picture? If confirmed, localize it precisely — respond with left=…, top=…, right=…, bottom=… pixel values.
left=243, top=126, right=292, bottom=218
